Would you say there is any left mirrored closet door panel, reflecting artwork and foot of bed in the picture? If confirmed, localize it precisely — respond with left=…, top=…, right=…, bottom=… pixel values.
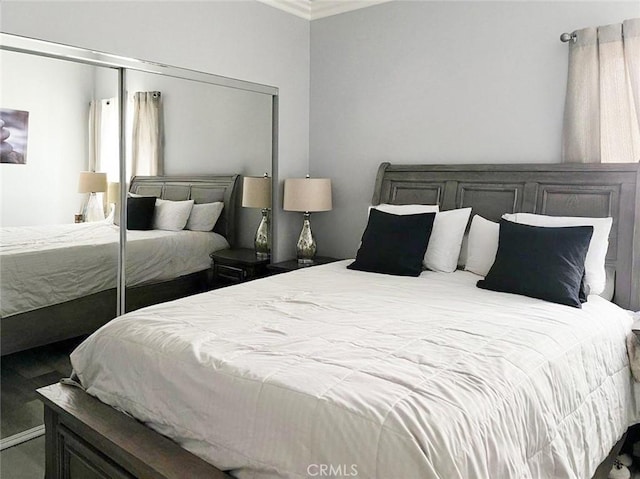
left=0, top=42, right=119, bottom=447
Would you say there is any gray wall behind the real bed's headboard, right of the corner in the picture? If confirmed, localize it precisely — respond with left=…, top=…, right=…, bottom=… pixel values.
left=309, top=1, right=640, bottom=257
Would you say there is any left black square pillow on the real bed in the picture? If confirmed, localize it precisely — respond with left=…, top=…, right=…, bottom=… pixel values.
left=347, top=209, right=436, bottom=276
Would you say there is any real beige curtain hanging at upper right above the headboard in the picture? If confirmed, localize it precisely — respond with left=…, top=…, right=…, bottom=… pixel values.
left=562, top=18, right=640, bottom=163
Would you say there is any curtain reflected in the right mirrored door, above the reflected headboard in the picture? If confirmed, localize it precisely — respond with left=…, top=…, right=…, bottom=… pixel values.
left=130, top=91, right=164, bottom=176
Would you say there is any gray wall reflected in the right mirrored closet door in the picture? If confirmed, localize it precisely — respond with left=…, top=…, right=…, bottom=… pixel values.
left=127, top=71, right=272, bottom=248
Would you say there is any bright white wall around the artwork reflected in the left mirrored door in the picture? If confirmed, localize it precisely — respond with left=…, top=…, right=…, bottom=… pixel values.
left=0, top=51, right=101, bottom=226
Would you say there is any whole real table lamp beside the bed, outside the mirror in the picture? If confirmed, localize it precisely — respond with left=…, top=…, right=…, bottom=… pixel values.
left=283, top=175, right=332, bottom=264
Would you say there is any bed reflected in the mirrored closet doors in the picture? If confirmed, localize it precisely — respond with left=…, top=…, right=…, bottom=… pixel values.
left=0, top=175, right=237, bottom=355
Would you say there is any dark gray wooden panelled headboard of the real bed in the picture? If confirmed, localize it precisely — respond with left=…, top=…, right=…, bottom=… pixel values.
left=372, top=163, right=640, bottom=311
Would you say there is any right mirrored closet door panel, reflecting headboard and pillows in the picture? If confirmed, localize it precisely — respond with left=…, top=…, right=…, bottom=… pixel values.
left=125, top=71, right=273, bottom=302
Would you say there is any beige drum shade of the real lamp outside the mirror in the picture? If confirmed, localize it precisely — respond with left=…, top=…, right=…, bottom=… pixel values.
left=283, top=178, right=332, bottom=213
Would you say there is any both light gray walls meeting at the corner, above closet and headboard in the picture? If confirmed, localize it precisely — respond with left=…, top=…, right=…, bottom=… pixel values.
left=0, top=1, right=640, bottom=259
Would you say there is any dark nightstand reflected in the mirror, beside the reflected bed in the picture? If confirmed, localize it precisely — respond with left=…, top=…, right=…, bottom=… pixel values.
left=209, top=248, right=269, bottom=287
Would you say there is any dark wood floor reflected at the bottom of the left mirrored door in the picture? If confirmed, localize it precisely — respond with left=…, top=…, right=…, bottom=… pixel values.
left=0, top=339, right=80, bottom=440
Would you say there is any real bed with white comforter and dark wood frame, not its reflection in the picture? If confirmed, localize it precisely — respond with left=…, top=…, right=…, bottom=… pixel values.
left=40, top=164, right=640, bottom=478
